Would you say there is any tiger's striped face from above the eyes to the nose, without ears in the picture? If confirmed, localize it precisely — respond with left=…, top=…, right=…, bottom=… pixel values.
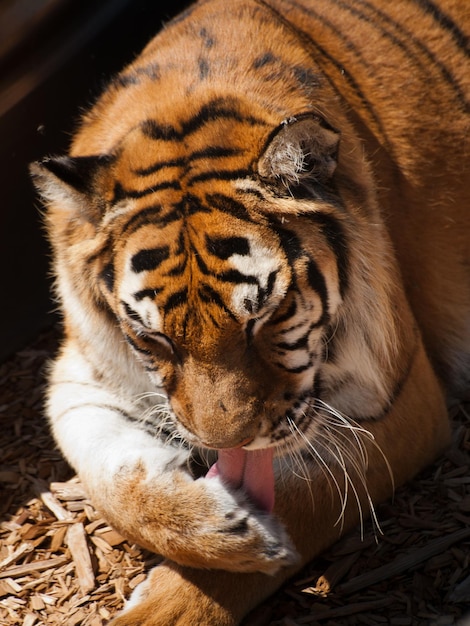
left=111, top=197, right=340, bottom=448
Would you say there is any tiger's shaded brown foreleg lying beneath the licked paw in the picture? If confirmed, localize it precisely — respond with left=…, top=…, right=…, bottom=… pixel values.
left=112, top=332, right=450, bottom=626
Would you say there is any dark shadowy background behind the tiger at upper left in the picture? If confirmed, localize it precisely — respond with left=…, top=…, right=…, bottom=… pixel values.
left=0, top=0, right=189, bottom=360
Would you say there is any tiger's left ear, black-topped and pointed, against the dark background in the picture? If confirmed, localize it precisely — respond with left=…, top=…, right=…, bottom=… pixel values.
left=30, top=156, right=110, bottom=221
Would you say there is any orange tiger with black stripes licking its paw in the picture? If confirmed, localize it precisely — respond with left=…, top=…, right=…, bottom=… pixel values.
left=31, top=0, right=470, bottom=626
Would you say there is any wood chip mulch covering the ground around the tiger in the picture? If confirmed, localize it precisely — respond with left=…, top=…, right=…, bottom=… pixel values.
left=0, top=329, right=470, bottom=626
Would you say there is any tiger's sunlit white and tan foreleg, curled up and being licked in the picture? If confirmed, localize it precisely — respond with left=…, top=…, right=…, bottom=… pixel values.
left=48, top=343, right=297, bottom=573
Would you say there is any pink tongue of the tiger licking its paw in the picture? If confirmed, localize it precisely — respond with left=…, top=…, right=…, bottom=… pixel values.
left=206, top=448, right=274, bottom=513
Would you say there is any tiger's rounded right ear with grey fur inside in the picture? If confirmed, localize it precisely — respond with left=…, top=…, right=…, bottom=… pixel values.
left=258, top=115, right=340, bottom=189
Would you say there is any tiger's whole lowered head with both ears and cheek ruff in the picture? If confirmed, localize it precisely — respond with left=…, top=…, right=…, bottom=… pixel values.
left=33, top=99, right=402, bottom=449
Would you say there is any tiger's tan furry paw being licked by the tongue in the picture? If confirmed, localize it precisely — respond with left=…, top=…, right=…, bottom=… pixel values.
left=99, top=460, right=298, bottom=575
